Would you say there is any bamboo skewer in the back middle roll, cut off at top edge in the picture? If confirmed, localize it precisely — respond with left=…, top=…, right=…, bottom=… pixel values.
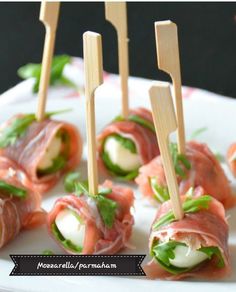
left=105, top=2, right=129, bottom=118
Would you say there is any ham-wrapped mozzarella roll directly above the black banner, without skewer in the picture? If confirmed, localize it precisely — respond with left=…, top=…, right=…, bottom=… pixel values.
left=48, top=181, right=134, bottom=254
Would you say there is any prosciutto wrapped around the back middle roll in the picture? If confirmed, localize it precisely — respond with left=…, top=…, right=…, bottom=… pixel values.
left=97, top=108, right=160, bottom=176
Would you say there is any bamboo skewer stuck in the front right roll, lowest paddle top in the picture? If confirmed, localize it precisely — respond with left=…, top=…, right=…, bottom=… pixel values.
left=149, top=82, right=184, bottom=220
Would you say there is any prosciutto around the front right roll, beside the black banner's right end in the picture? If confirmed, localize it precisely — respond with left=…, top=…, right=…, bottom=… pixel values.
left=144, top=188, right=231, bottom=280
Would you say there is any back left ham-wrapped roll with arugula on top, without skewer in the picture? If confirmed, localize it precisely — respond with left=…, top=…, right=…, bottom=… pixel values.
left=0, top=114, right=82, bottom=193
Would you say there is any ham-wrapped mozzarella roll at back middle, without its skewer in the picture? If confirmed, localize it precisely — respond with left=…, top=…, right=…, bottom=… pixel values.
left=98, top=108, right=159, bottom=180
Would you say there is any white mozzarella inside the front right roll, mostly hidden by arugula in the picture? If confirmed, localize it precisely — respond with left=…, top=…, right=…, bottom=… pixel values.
left=170, top=245, right=208, bottom=268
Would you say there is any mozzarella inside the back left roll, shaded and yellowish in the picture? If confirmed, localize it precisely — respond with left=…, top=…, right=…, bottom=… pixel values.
left=38, top=136, right=62, bottom=170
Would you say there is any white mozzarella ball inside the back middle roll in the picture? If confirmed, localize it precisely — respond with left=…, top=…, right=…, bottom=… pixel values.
left=104, top=137, right=141, bottom=171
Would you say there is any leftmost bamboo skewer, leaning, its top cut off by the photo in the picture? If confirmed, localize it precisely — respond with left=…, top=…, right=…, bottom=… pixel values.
left=36, top=1, right=60, bottom=121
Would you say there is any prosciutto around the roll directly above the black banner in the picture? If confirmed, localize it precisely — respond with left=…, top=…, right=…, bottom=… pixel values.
left=48, top=181, right=134, bottom=254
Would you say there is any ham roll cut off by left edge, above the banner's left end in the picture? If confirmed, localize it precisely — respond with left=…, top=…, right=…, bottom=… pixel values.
left=0, top=157, right=46, bottom=248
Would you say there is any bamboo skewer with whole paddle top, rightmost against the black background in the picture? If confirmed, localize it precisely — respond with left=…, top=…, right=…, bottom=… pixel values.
left=155, top=20, right=185, bottom=154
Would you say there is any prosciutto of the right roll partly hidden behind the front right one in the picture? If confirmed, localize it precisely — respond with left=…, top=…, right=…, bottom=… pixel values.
left=135, top=141, right=236, bottom=208
